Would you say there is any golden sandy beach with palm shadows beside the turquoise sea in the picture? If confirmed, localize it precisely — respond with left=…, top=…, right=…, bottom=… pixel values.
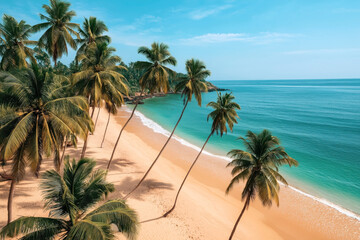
left=0, top=108, right=360, bottom=240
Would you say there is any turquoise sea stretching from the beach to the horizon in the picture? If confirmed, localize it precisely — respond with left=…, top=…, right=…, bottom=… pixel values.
left=138, top=79, right=360, bottom=214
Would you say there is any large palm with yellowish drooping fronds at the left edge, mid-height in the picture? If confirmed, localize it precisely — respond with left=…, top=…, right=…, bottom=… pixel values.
left=0, top=65, right=93, bottom=222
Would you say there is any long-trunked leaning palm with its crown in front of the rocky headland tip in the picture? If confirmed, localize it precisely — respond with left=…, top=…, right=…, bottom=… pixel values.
left=125, top=59, right=211, bottom=198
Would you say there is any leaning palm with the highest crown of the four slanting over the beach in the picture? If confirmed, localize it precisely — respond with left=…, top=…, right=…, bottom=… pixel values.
left=107, top=42, right=176, bottom=170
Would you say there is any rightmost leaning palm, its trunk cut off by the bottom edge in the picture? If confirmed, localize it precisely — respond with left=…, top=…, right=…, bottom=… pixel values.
left=226, top=129, right=298, bottom=240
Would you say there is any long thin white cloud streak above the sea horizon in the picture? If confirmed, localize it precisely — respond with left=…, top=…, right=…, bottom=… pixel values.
left=180, top=32, right=299, bottom=45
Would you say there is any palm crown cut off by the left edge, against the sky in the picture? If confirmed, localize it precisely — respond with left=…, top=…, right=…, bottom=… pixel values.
left=0, top=14, right=37, bottom=70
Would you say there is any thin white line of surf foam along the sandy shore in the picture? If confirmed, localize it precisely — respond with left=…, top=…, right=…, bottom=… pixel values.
left=126, top=108, right=360, bottom=221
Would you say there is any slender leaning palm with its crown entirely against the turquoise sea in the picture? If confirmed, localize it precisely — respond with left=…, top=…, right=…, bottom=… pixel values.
left=164, top=93, right=240, bottom=217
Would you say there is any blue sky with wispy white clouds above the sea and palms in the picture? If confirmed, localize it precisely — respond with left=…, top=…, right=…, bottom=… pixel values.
left=0, top=0, right=360, bottom=80
